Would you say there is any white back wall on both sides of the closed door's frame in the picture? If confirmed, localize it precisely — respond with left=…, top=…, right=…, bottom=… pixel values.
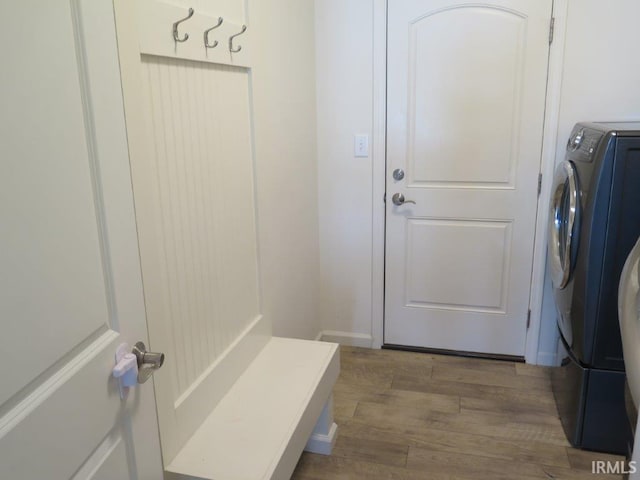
left=316, top=0, right=640, bottom=363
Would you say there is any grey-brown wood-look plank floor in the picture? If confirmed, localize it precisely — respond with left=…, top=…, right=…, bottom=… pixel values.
left=292, top=347, right=623, bottom=480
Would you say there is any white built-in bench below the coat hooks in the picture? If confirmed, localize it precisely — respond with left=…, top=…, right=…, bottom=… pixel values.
left=165, top=337, right=340, bottom=480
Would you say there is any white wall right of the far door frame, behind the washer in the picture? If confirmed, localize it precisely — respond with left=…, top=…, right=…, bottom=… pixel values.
left=538, top=0, right=640, bottom=363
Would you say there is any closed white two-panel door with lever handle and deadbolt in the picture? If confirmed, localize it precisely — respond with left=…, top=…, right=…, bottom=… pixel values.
left=384, top=0, right=552, bottom=356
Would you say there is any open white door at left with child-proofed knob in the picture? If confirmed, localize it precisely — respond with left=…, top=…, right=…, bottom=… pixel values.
left=0, top=0, right=162, bottom=480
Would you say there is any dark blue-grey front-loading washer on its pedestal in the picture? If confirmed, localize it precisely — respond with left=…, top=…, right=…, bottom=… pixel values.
left=548, top=122, right=640, bottom=453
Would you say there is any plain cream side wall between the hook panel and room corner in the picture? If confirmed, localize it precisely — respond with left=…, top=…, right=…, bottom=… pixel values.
left=248, top=0, right=319, bottom=338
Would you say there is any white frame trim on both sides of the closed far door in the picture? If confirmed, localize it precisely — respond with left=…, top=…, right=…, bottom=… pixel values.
left=371, top=0, right=569, bottom=364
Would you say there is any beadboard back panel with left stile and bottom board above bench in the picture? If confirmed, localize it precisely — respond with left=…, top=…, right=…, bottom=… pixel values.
left=116, top=1, right=264, bottom=465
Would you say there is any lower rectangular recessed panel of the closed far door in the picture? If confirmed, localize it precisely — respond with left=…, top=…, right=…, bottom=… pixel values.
left=404, top=218, right=512, bottom=314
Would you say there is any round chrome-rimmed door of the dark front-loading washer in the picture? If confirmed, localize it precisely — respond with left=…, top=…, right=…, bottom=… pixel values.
left=548, top=160, right=580, bottom=289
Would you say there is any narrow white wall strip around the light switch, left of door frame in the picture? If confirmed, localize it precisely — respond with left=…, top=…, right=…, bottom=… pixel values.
left=316, top=0, right=373, bottom=346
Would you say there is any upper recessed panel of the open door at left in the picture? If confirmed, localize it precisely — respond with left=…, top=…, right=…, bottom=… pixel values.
left=0, top=0, right=110, bottom=403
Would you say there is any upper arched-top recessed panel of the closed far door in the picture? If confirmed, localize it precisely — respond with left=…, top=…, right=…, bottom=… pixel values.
left=407, top=6, right=527, bottom=188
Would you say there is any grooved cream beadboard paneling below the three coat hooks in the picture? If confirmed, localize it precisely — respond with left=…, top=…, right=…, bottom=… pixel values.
left=142, top=56, right=260, bottom=402
